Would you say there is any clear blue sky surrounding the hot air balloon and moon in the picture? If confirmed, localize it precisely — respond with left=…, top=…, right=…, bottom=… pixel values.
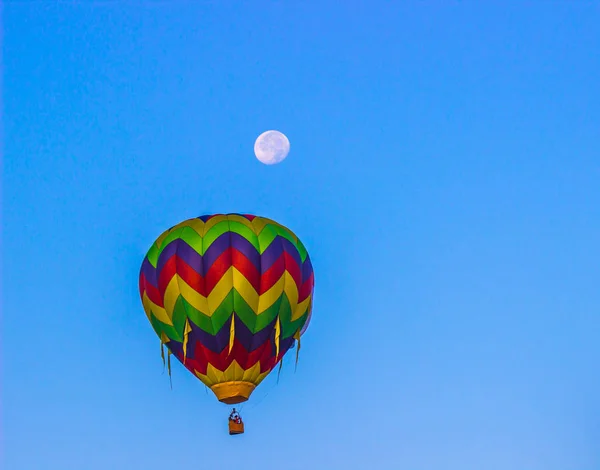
left=2, top=0, right=600, bottom=470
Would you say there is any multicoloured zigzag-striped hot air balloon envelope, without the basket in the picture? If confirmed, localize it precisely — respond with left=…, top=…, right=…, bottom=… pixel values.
left=140, top=214, right=314, bottom=404
